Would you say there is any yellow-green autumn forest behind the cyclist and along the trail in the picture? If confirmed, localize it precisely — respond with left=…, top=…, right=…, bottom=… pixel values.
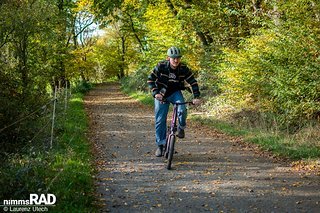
left=0, top=0, right=320, bottom=211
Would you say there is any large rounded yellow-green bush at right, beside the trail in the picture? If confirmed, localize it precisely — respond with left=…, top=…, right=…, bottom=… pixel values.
left=219, top=26, right=320, bottom=127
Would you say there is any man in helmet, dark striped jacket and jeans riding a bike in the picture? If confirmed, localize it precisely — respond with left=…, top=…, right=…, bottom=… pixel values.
left=148, top=47, right=200, bottom=157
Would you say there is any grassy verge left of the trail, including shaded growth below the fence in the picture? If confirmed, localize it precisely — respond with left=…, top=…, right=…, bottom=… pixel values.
left=0, top=93, right=96, bottom=212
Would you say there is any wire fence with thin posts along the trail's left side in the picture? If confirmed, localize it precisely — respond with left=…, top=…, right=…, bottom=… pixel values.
left=0, top=81, right=71, bottom=152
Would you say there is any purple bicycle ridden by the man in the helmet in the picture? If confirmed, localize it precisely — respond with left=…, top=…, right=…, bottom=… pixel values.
left=164, top=101, right=193, bottom=170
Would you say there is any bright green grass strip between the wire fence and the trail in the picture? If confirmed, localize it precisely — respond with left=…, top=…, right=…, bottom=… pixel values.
left=50, top=93, right=94, bottom=212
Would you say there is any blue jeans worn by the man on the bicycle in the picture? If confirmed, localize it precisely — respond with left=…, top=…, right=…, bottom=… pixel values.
left=154, top=91, right=187, bottom=146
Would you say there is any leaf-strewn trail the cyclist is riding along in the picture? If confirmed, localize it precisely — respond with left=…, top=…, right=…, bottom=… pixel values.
left=85, top=83, right=320, bottom=213
